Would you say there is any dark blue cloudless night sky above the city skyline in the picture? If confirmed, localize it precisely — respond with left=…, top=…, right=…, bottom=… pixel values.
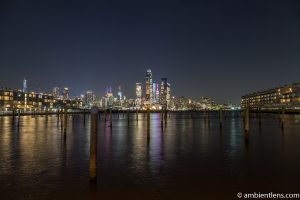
left=0, top=0, right=300, bottom=103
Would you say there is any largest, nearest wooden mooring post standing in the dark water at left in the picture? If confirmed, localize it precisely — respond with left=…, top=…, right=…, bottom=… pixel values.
left=90, top=107, right=98, bottom=182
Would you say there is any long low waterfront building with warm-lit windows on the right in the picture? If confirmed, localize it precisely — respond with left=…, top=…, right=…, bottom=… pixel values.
left=241, top=83, right=300, bottom=109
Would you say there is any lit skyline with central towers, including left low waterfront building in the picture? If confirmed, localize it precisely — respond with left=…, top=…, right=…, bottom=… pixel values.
left=0, top=69, right=218, bottom=111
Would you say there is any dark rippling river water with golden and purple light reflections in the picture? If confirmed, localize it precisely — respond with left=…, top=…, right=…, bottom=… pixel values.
left=0, top=113, right=300, bottom=200
